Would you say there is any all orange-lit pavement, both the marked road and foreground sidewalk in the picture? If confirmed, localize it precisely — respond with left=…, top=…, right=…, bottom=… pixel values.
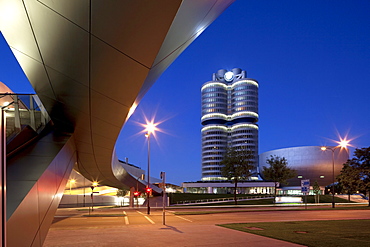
left=44, top=207, right=370, bottom=247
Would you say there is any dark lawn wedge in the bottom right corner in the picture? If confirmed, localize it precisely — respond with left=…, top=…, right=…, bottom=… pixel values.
left=218, top=220, right=370, bottom=247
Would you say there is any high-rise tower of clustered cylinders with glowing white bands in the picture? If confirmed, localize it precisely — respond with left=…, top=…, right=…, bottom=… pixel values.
left=201, top=68, right=258, bottom=181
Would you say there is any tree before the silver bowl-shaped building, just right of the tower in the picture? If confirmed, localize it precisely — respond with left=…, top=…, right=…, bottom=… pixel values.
left=262, top=155, right=297, bottom=203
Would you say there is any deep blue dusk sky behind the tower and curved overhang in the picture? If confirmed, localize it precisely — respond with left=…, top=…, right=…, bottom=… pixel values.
left=0, top=0, right=370, bottom=185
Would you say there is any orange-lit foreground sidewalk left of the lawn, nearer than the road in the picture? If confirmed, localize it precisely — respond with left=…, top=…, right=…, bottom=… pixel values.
left=44, top=207, right=301, bottom=247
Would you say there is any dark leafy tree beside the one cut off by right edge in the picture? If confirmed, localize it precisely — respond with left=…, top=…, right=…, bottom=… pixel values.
left=337, top=160, right=361, bottom=202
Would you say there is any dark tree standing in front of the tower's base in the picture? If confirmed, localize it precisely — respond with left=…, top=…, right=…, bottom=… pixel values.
left=220, top=148, right=255, bottom=205
